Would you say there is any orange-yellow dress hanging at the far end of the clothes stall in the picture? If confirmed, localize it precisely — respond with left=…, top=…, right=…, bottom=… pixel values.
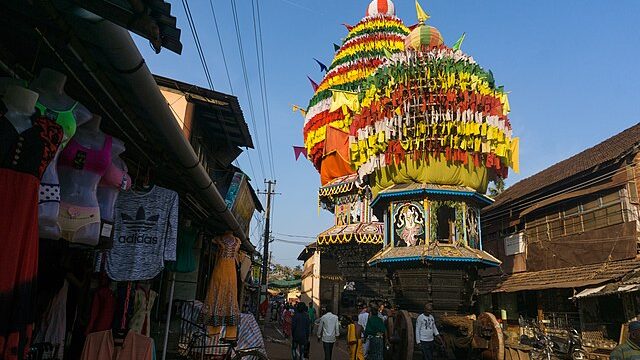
left=203, top=232, right=240, bottom=339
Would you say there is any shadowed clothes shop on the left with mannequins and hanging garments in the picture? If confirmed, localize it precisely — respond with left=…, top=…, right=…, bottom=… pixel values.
left=0, top=1, right=261, bottom=359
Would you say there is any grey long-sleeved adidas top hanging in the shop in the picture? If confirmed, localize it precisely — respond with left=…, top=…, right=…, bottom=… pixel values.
left=105, top=186, right=178, bottom=281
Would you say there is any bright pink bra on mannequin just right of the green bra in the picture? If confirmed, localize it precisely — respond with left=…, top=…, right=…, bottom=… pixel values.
left=58, top=135, right=112, bottom=176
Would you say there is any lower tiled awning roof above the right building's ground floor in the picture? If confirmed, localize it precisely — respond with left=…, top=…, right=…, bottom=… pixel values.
left=478, top=258, right=640, bottom=294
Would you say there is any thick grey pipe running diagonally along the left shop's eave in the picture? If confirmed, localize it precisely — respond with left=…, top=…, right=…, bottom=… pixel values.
left=69, top=12, right=255, bottom=250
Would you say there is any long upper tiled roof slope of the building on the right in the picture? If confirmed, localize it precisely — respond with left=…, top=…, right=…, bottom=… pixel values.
left=484, top=123, right=640, bottom=212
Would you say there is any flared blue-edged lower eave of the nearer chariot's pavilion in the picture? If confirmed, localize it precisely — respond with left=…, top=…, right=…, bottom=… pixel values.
left=368, top=243, right=500, bottom=265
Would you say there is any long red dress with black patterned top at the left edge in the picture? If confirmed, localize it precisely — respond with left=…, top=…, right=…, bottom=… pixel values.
left=0, top=102, right=63, bottom=359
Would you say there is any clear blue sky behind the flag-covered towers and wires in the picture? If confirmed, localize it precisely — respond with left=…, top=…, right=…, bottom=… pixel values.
left=136, top=0, right=640, bottom=265
